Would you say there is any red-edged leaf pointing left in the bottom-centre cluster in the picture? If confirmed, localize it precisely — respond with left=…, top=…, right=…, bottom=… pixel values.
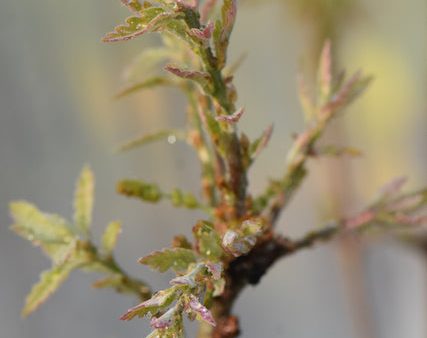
left=120, top=287, right=178, bottom=320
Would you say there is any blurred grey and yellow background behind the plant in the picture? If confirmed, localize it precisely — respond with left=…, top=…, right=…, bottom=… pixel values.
left=0, top=0, right=427, bottom=338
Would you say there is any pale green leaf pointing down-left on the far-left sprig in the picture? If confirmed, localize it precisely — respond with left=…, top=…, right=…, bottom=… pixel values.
left=22, top=262, right=77, bottom=316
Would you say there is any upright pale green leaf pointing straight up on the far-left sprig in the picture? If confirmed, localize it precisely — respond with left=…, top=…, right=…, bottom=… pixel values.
left=74, top=167, right=95, bottom=234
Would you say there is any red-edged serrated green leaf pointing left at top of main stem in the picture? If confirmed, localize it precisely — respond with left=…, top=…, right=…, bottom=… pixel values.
left=103, top=7, right=177, bottom=42
